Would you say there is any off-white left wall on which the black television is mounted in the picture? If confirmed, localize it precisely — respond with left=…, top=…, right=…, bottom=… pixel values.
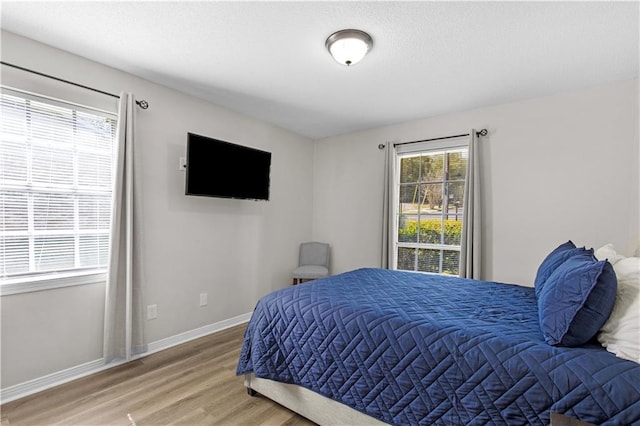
left=0, top=32, right=313, bottom=389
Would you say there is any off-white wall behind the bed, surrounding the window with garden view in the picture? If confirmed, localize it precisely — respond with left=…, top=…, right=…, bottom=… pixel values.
left=313, top=79, right=640, bottom=285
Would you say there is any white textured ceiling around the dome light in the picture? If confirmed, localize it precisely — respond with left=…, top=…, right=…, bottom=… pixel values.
left=1, top=0, right=640, bottom=139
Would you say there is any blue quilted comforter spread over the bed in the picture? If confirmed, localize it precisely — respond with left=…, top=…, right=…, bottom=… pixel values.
left=237, top=269, right=640, bottom=425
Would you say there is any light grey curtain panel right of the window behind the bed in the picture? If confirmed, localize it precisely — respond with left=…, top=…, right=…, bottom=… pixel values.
left=460, top=129, right=482, bottom=280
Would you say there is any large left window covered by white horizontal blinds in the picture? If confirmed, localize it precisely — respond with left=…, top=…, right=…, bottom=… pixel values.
left=0, top=88, right=117, bottom=281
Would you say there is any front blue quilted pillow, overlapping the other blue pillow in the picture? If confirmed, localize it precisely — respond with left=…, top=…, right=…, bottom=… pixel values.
left=538, top=252, right=618, bottom=346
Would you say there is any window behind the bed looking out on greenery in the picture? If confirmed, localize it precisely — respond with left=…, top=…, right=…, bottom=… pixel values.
left=394, top=140, right=468, bottom=275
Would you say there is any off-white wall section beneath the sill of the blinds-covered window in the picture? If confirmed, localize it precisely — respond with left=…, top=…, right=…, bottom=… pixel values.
left=0, top=284, right=105, bottom=389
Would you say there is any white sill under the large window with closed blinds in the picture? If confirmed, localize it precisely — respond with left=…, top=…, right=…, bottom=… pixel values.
left=0, top=270, right=107, bottom=296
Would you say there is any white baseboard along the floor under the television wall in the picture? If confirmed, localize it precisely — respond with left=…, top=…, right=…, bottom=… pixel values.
left=0, top=312, right=251, bottom=404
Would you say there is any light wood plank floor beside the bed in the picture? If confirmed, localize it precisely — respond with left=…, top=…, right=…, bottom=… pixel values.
left=0, top=325, right=313, bottom=426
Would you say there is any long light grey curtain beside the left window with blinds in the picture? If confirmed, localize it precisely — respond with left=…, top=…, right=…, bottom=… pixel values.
left=103, top=93, right=146, bottom=363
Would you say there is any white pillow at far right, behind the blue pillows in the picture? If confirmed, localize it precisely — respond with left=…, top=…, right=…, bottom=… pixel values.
left=596, top=244, right=640, bottom=363
